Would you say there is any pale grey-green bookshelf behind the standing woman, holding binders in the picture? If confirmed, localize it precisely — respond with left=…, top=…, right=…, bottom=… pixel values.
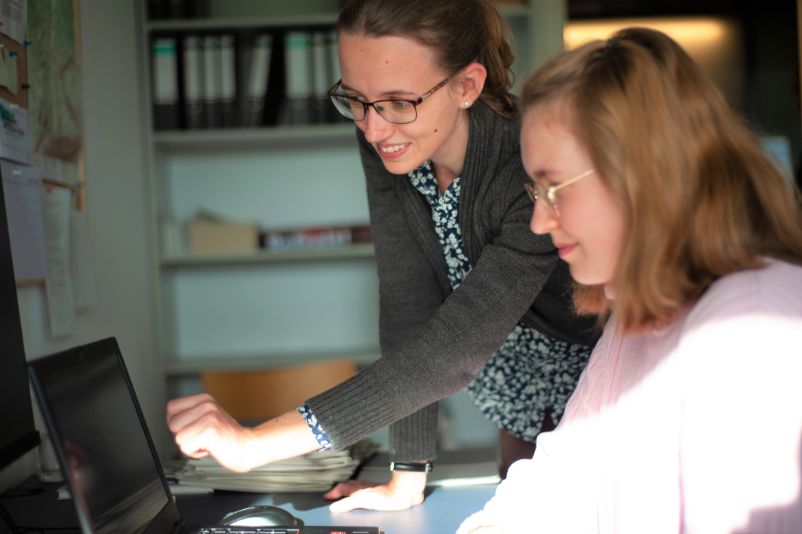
left=139, top=0, right=565, bottom=395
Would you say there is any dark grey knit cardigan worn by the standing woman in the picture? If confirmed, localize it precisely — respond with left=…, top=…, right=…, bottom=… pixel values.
left=307, top=102, right=597, bottom=461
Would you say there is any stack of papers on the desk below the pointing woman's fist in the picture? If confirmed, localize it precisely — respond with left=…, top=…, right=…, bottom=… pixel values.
left=173, top=443, right=376, bottom=493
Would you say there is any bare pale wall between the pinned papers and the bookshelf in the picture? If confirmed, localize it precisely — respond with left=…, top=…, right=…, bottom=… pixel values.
left=0, top=0, right=159, bottom=488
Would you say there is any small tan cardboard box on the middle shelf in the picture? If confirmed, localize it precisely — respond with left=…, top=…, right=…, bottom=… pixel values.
left=188, top=220, right=259, bottom=254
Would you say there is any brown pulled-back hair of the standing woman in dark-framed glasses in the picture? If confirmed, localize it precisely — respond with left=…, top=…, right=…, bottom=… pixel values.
left=337, top=0, right=517, bottom=117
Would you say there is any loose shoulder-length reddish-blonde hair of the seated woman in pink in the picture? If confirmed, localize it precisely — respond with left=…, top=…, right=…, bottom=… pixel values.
left=521, top=28, right=802, bottom=332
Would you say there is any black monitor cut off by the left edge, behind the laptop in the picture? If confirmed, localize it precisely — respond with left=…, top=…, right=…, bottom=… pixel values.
left=0, top=172, right=39, bottom=469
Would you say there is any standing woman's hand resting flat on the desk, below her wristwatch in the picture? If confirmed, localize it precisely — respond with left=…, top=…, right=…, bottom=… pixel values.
left=323, top=471, right=426, bottom=512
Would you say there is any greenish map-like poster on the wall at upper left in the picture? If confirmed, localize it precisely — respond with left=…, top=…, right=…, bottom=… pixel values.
left=27, top=0, right=83, bottom=196
